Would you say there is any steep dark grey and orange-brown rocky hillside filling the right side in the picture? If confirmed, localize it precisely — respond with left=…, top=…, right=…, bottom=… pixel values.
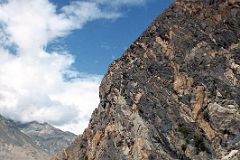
left=53, top=0, right=240, bottom=160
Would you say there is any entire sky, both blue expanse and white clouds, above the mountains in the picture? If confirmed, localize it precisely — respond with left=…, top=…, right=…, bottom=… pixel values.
left=0, top=0, right=171, bottom=134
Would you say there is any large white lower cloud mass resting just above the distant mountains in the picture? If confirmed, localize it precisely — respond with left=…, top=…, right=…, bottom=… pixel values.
left=0, top=49, right=101, bottom=133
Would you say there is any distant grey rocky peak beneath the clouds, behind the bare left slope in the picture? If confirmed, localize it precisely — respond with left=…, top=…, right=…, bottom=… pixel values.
left=16, top=121, right=76, bottom=154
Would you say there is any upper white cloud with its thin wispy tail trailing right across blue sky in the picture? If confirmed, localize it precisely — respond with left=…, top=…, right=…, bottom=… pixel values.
left=0, top=0, right=119, bottom=50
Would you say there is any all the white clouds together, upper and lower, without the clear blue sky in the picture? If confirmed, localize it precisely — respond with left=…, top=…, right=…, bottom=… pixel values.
left=0, top=0, right=145, bottom=134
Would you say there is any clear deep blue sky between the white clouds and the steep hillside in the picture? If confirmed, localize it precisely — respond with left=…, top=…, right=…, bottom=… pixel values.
left=49, top=0, right=171, bottom=74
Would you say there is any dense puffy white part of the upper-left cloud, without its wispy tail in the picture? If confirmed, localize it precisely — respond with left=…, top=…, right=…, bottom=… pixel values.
left=0, top=0, right=70, bottom=50
